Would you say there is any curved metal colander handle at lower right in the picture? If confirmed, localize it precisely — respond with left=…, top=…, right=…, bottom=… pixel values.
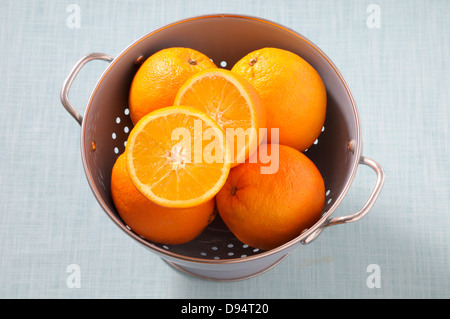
left=302, top=156, right=385, bottom=244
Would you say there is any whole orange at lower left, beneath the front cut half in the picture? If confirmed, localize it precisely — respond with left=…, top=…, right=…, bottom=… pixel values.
left=111, top=154, right=215, bottom=245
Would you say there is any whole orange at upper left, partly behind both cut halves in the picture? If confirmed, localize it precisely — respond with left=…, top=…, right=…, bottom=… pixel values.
left=129, top=47, right=216, bottom=124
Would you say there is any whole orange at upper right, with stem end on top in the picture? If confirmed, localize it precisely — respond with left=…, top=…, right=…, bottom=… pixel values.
left=231, top=48, right=327, bottom=151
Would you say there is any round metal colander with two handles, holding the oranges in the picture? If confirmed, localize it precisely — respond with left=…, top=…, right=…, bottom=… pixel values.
left=61, top=14, right=384, bottom=280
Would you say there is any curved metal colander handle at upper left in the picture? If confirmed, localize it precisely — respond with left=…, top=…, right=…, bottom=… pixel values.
left=60, top=53, right=114, bottom=125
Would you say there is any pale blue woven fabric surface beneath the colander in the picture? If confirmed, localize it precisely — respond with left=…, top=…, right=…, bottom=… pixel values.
left=0, top=0, right=450, bottom=298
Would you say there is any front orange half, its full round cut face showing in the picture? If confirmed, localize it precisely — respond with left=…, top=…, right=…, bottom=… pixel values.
left=125, top=106, right=231, bottom=208
